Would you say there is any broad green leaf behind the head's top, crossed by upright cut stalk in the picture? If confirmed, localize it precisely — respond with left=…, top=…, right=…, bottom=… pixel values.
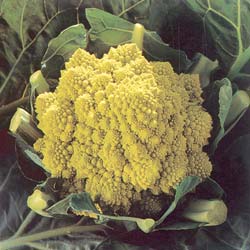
left=86, top=8, right=190, bottom=72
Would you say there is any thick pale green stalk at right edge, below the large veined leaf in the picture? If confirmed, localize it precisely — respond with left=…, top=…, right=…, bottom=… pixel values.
left=227, top=46, right=250, bottom=81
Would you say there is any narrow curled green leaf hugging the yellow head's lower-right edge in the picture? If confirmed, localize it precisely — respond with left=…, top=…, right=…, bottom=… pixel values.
left=156, top=176, right=201, bottom=226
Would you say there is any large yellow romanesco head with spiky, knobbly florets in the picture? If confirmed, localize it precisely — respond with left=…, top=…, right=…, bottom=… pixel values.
left=34, top=43, right=212, bottom=213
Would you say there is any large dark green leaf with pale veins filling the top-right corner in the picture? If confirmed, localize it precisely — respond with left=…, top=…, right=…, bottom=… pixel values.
left=185, top=0, right=250, bottom=80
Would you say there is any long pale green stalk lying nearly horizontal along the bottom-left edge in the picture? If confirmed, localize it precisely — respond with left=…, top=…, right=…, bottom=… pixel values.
left=0, top=225, right=105, bottom=250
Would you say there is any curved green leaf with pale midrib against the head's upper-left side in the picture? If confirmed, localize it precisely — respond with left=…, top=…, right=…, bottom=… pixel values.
left=41, top=24, right=87, bottom=78
